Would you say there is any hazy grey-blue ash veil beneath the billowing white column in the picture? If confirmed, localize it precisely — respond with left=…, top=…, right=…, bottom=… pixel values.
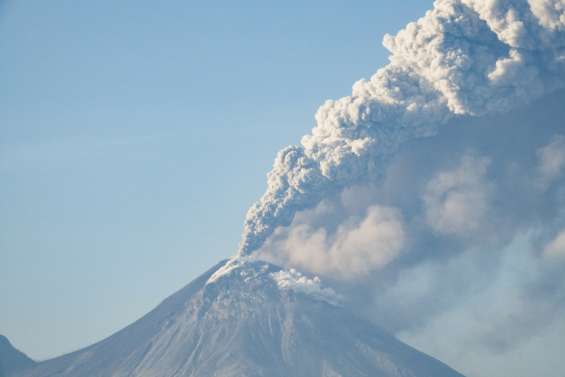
left=256, top=91, right=565, bottom=377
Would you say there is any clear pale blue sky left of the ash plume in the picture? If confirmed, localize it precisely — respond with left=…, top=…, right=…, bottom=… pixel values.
left=0, top=0, right=431, bottom=359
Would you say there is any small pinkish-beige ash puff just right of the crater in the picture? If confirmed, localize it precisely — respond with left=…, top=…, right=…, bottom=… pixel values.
left=258, top=205, right=406, bottom=279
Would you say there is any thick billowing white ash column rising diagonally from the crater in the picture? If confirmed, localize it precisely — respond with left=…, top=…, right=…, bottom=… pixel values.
left=238, top=0, right=565, bottom=256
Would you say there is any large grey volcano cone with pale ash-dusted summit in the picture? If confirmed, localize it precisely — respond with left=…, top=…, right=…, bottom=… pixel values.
left=16, top=262, right=461, bottom=377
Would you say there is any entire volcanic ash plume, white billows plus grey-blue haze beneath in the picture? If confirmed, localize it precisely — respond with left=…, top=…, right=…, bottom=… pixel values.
left=230, top=0, right=565, bottom=377
